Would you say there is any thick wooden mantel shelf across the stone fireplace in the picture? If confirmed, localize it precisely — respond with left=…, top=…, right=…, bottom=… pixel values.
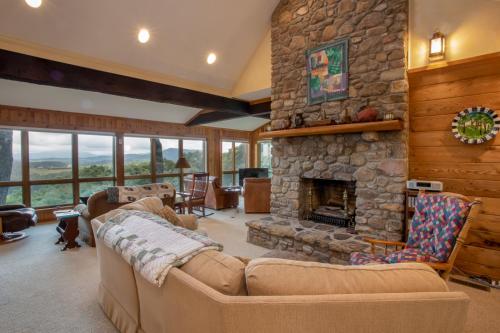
left=259, top=120, right=404, bottom=139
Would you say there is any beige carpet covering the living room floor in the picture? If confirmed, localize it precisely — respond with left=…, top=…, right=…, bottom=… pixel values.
left=0, top=210, right=500, bottom=333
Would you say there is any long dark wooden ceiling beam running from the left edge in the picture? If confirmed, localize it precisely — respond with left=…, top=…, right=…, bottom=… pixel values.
left=0, top=50, right=250, bottom=112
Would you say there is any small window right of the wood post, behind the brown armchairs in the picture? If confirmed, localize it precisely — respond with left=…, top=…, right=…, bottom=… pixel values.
left=222, top=141, right=248, bottom=186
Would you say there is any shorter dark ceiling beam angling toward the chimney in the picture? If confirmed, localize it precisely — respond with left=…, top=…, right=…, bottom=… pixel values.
left=185, top=101, right=271, bottom=126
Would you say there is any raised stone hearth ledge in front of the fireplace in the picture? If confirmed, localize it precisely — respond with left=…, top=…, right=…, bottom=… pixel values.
left=246, top=216, right=370, bottom=264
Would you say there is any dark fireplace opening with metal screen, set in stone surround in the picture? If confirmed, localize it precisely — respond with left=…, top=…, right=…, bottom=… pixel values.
left=301, top=178, right=356, bottom=228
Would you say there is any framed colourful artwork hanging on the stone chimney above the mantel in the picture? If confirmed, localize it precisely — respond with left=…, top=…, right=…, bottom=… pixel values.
left=306, top=38, right=349, bottom=105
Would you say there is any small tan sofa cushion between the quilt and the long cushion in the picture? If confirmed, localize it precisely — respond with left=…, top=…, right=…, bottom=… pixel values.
left=181, top=250, right=246, bottom=295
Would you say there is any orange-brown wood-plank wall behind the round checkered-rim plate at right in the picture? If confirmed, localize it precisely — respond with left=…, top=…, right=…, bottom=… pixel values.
left=408, top=53, right=500, bottom=280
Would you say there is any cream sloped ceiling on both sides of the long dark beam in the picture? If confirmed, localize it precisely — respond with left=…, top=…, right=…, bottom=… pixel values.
left=0, top=0, right=279, bottom=127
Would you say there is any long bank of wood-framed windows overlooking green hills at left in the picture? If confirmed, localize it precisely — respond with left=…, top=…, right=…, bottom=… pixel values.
left=0, top=128, right=209, bottom=208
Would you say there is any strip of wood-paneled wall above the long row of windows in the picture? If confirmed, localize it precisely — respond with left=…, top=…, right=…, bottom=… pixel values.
left=0, top=105, right=252, bottom=180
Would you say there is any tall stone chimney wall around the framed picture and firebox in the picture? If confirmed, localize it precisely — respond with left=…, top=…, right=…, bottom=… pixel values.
left=271, top=0, right=408, bottom=240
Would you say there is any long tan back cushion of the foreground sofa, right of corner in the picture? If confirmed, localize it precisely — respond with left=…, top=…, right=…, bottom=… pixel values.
left=245, top=258, right=448, bottom=296
